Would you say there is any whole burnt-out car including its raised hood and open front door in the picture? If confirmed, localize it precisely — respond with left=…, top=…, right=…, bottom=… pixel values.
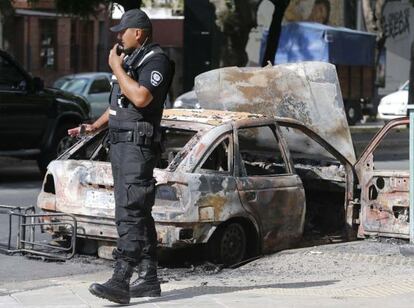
left=37, top=64, right=408, bottom=264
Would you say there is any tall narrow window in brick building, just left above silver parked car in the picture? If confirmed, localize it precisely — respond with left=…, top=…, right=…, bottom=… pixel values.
left=40, top=19, right=56, bottom=68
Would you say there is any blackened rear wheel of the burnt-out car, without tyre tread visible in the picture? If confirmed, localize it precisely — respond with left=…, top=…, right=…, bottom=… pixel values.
left=220, top=223, right=246, bottom=264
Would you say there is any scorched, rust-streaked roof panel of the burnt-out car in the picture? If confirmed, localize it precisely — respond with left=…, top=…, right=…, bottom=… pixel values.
left=163, top=109, right=266, bottom=126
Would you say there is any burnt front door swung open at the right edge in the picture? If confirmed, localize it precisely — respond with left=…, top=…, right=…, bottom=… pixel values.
left=355, top=118, right=410, bottom=239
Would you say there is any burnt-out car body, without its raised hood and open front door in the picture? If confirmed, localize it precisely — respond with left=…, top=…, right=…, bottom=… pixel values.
left=38, top=110, right=352, bottom=264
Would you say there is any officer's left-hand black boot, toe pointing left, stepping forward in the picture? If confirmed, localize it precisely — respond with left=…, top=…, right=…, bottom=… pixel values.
left=89, top=260, right=133, bottom=304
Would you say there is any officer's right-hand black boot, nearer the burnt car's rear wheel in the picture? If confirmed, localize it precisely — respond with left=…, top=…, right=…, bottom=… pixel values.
left=129, top=259, right=161, bottom=297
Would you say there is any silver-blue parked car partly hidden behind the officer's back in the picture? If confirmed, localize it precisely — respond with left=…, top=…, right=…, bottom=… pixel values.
left=53, top=72, right=112, bottom=120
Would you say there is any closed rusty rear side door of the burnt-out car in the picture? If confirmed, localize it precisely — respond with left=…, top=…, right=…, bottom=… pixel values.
left=235, top=123, right=305, bottom=252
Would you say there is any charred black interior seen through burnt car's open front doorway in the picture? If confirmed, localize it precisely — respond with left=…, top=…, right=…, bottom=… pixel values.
left=281, top=127, right=346, bottom=243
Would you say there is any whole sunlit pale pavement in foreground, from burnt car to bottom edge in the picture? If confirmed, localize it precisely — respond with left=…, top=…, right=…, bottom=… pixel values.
left=4, top=242, right=414, bottom=308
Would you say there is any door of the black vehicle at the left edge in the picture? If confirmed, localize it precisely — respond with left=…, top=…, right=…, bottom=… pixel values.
left=0, top=54, right=49, bottom=151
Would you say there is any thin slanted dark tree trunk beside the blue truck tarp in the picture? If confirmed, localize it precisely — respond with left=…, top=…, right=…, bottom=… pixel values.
left=262, top=0, right=290, bottom=66
